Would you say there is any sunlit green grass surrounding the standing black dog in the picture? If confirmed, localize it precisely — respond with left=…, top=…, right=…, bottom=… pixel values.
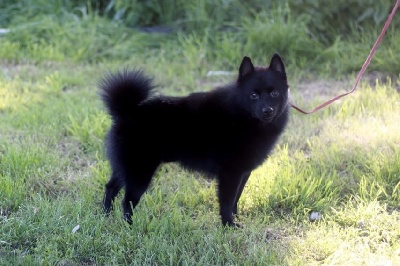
left=0, top=1, right=400, bottom=265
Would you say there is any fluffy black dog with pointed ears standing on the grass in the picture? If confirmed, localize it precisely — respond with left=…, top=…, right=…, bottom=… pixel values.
left=100, top=54, right=289, bottom=226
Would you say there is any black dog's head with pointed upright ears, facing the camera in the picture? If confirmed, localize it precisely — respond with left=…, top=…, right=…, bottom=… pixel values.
left=237, top=53, right=289, bottom=123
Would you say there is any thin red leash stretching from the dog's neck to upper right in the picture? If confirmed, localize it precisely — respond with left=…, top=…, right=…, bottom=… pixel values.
left=290, top=0, right=400, bottom=115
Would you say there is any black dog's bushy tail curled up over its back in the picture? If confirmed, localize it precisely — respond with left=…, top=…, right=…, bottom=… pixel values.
left=100, top=69, right=154, bottom=119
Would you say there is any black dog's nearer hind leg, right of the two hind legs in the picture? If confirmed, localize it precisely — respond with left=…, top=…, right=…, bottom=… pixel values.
left=122, top=163, right=158, bottom=224
